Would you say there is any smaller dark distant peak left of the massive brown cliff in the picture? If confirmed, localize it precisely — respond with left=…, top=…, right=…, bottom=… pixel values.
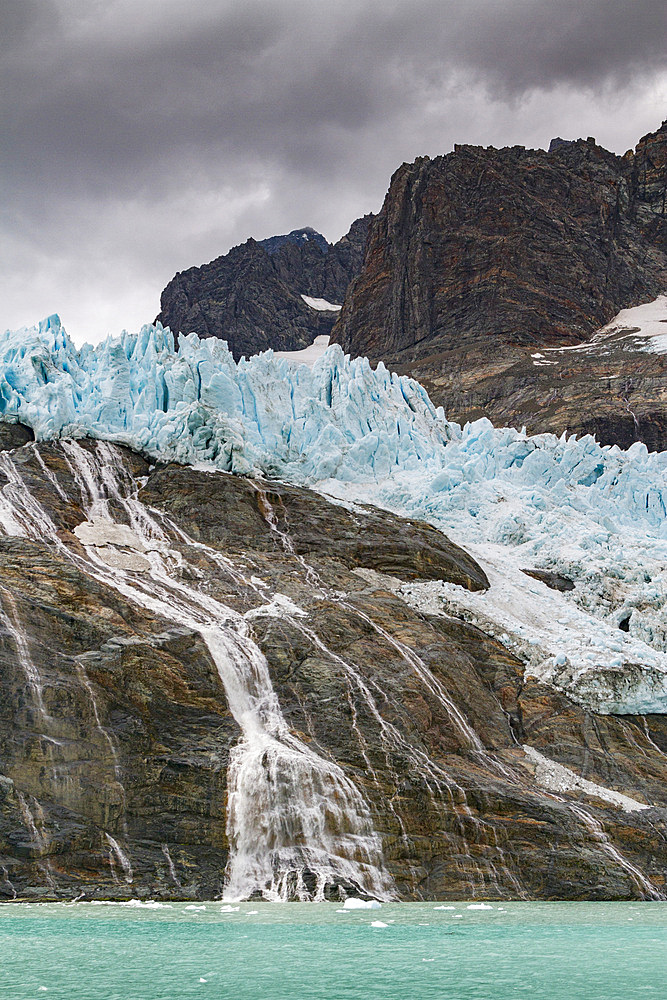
left=157, top=215, right=372, bottom=360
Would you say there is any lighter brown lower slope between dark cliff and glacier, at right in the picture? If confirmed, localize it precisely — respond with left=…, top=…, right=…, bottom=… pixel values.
left=408, top=297, right=667, bottom=451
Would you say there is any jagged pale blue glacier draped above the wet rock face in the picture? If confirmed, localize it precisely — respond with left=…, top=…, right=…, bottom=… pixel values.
left=0, top=316, right=667, bottom=713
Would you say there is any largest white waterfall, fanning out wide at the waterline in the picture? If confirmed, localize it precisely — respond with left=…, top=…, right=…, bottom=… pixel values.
left=0, top=441, right=394, bottom=899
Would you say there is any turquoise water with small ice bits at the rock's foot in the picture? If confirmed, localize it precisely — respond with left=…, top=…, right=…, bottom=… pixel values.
left=0, top=903, right=667, bottom=1000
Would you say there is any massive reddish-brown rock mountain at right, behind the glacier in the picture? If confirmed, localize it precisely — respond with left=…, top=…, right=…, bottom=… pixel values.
left=332, top=123, right=667, bottom=447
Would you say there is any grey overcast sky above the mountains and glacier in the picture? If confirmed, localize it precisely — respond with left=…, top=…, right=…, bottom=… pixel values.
left=0, top=0, right=667, bottom=342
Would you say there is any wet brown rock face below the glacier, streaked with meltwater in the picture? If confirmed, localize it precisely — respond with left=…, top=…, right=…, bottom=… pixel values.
left=0, top=428, right=667, bottom=899
